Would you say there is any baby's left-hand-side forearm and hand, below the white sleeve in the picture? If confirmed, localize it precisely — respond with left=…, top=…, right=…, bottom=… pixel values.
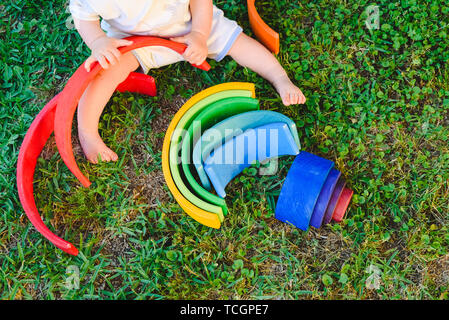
left=73, top=18, right=132, bottom=71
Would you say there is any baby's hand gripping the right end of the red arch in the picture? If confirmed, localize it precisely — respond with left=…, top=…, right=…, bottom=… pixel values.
left=170, top=31, right=207, bottom=66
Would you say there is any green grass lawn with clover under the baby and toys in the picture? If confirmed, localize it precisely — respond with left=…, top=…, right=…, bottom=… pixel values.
left=0, top=0, right=449, bottom=299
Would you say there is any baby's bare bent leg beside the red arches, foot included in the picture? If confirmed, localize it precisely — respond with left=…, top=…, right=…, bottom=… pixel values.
left=78, top=52, right=139, bottom=163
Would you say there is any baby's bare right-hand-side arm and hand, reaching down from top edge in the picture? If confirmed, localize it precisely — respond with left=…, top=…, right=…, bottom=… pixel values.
left=171, top=0, right=213, bottom=65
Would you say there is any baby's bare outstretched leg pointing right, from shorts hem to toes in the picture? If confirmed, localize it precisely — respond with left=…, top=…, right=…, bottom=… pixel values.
left=228, top=33, right=306, bottom=105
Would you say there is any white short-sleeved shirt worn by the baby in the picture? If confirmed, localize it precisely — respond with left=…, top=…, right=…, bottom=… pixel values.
left=69, top=0, right=191, bottom=37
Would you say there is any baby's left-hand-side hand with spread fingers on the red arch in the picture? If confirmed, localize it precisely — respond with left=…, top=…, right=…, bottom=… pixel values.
left=84, top=36, right=133, bottom=72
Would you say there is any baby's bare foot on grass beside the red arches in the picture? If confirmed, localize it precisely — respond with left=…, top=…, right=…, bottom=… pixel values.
left=78, top=129, right=118, bottom=163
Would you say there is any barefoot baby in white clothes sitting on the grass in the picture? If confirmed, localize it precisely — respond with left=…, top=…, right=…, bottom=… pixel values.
left=70, top=0, right=306, bottom=163
